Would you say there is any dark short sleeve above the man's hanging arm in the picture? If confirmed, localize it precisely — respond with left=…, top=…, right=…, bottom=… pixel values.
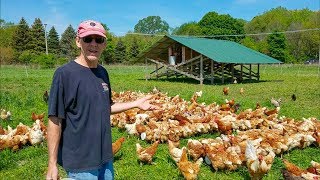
left=48, top=69, right=65, bottom=119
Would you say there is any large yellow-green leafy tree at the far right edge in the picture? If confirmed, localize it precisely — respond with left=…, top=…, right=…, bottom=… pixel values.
left=245, top=7, right=320, bottom=63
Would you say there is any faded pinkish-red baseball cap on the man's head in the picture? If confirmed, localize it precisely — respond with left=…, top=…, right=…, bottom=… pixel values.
left=77, top=20, right=106, bottom=38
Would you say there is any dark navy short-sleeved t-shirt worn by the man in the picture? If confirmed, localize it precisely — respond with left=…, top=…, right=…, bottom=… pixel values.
left=48, top=61, right=113, bottom=172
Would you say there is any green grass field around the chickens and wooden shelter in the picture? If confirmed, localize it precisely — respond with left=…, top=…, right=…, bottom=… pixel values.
left=0, top=65, right=320, bottom=180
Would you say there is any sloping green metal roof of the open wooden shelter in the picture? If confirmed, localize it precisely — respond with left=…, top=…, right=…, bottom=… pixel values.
left=139, top=36, right=282, bottom=64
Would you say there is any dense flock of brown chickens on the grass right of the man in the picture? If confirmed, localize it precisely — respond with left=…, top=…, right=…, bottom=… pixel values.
left=111, top=89, right=320, bottom=179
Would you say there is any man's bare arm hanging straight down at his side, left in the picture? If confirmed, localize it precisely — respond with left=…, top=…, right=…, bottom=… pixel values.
left=46, top=116, right=61, bottom=180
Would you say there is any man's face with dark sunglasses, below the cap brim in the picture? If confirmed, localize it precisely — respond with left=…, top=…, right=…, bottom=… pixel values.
left=76, top=35, right=106, bottom=61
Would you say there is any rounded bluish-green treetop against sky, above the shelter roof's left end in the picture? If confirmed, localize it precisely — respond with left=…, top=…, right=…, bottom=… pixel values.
left=134, top=16, right=169, bottom=34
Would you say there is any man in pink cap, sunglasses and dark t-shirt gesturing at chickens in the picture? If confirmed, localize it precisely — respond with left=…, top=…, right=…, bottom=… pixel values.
left=46, top=20, right=156, bottom=179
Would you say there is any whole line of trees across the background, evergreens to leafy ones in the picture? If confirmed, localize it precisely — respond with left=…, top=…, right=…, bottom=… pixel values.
left=0, top=7, right=320, bottom=67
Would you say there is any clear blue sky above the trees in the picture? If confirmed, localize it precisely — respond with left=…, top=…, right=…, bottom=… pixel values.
left=0, top=0, right=320, bottom=36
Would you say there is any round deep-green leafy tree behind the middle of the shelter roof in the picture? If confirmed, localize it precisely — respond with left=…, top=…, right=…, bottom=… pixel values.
left=199, top=12, right=244, bottom=42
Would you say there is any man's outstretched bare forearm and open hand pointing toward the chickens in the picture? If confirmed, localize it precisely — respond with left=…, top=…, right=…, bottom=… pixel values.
left=111, top=95, right=158, bottom=114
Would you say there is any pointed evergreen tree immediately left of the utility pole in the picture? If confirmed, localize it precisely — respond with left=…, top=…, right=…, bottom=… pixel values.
left=28, top=18, right=46, bottom=54
